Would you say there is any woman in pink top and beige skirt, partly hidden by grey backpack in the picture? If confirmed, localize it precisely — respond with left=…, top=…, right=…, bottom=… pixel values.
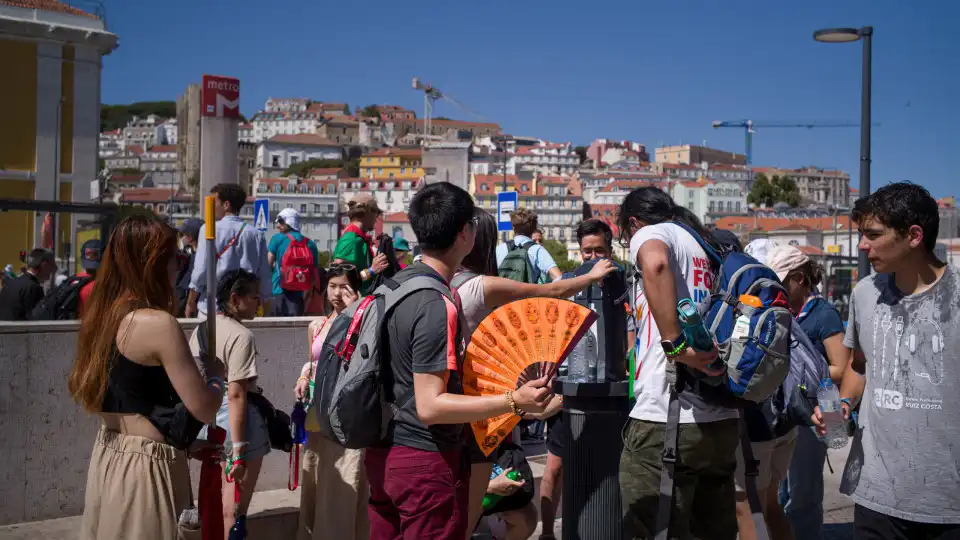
left=294, top=263, right=370, bottom=540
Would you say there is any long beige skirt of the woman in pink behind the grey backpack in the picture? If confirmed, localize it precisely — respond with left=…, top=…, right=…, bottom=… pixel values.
left=297, top=432, right=370, bottom=540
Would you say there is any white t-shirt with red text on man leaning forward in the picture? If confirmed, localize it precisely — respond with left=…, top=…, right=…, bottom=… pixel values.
left=630, top=223, right=738, bottom=424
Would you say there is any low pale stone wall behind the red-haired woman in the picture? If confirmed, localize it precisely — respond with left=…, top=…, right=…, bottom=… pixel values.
left=0, top=318, right=310, bottom=525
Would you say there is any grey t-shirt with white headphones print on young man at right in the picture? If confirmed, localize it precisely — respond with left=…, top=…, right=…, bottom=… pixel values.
left=841, top=266, right=960, bottom=523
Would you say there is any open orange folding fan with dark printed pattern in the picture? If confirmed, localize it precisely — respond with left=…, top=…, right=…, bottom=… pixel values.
left=463, top=298, right=597, bottom=455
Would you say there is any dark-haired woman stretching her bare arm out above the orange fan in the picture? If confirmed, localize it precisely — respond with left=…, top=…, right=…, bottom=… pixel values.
left=458, top=208, right=615, bottom=540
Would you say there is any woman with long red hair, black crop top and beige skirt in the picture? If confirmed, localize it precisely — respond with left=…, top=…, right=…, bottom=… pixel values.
left=69, top=216, right=224, bottom=540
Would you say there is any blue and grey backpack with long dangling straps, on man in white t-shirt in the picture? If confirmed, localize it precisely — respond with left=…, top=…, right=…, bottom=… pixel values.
left=655, top=223, right=794, bottom=540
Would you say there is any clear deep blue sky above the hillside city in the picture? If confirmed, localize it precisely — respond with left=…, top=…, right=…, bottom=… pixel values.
left=102, top=0, right=960, bottom=196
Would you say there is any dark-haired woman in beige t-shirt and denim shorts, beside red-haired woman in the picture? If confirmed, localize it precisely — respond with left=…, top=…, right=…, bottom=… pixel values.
left=190, top=268, right=270, bottom=531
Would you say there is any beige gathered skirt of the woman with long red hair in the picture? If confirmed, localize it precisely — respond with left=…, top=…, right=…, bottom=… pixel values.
left=80, top=428, right=191, bottom=540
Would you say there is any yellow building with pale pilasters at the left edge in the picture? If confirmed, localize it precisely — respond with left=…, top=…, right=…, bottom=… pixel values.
left=0, top=0, right=117, bottom=267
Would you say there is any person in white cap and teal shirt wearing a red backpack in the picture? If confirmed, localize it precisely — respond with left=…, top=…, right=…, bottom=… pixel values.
left=267, top=208, right=320, bottom=317
